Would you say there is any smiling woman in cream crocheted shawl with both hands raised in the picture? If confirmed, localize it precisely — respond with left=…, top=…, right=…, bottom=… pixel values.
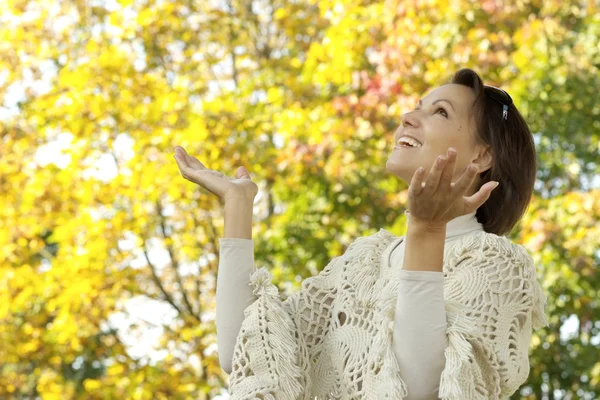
left=176, top=69, right=547, bottom=400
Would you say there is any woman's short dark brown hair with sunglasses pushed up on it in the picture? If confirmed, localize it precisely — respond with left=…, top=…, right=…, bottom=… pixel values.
left=450, top=68, right=537, bottom=236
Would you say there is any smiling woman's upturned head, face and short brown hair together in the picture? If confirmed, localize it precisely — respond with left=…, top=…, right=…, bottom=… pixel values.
left=386, top=69, right=537, bottom=235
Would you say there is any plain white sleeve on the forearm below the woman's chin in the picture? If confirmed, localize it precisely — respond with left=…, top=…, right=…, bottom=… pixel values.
left=393, top=270, right=448, bottom=400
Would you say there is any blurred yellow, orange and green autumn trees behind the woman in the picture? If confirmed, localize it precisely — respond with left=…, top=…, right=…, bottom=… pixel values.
left=0, top=0, right=600, bottom=400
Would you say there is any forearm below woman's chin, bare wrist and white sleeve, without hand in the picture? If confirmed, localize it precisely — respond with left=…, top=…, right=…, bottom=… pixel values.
left=393, top=222, right=448, bottom=400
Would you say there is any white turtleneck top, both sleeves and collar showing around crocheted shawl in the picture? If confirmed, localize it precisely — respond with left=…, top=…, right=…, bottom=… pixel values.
left=216, top=212, right=483, bottom=399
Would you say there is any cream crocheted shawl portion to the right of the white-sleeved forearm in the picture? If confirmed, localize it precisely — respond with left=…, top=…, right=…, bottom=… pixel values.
left=439, top=238, right=548, bottom=400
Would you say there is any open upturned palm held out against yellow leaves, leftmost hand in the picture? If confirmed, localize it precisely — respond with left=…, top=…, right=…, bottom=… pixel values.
left=174, top=146, right=258, bottom=202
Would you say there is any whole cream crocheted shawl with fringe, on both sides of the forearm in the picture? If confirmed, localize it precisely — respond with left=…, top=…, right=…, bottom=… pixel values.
left=229, top=229, right=548, bottom=400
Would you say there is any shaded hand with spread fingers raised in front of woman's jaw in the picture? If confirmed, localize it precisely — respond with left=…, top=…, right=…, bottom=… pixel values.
left=408, top=147, right=498, bottom=232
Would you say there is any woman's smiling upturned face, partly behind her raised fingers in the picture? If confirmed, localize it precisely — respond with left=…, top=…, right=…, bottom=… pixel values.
left=386, top=84, right=492, bottom=194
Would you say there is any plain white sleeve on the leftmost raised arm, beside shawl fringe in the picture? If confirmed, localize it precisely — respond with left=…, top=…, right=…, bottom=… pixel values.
left=216, top=238, right=256, bottom=374
